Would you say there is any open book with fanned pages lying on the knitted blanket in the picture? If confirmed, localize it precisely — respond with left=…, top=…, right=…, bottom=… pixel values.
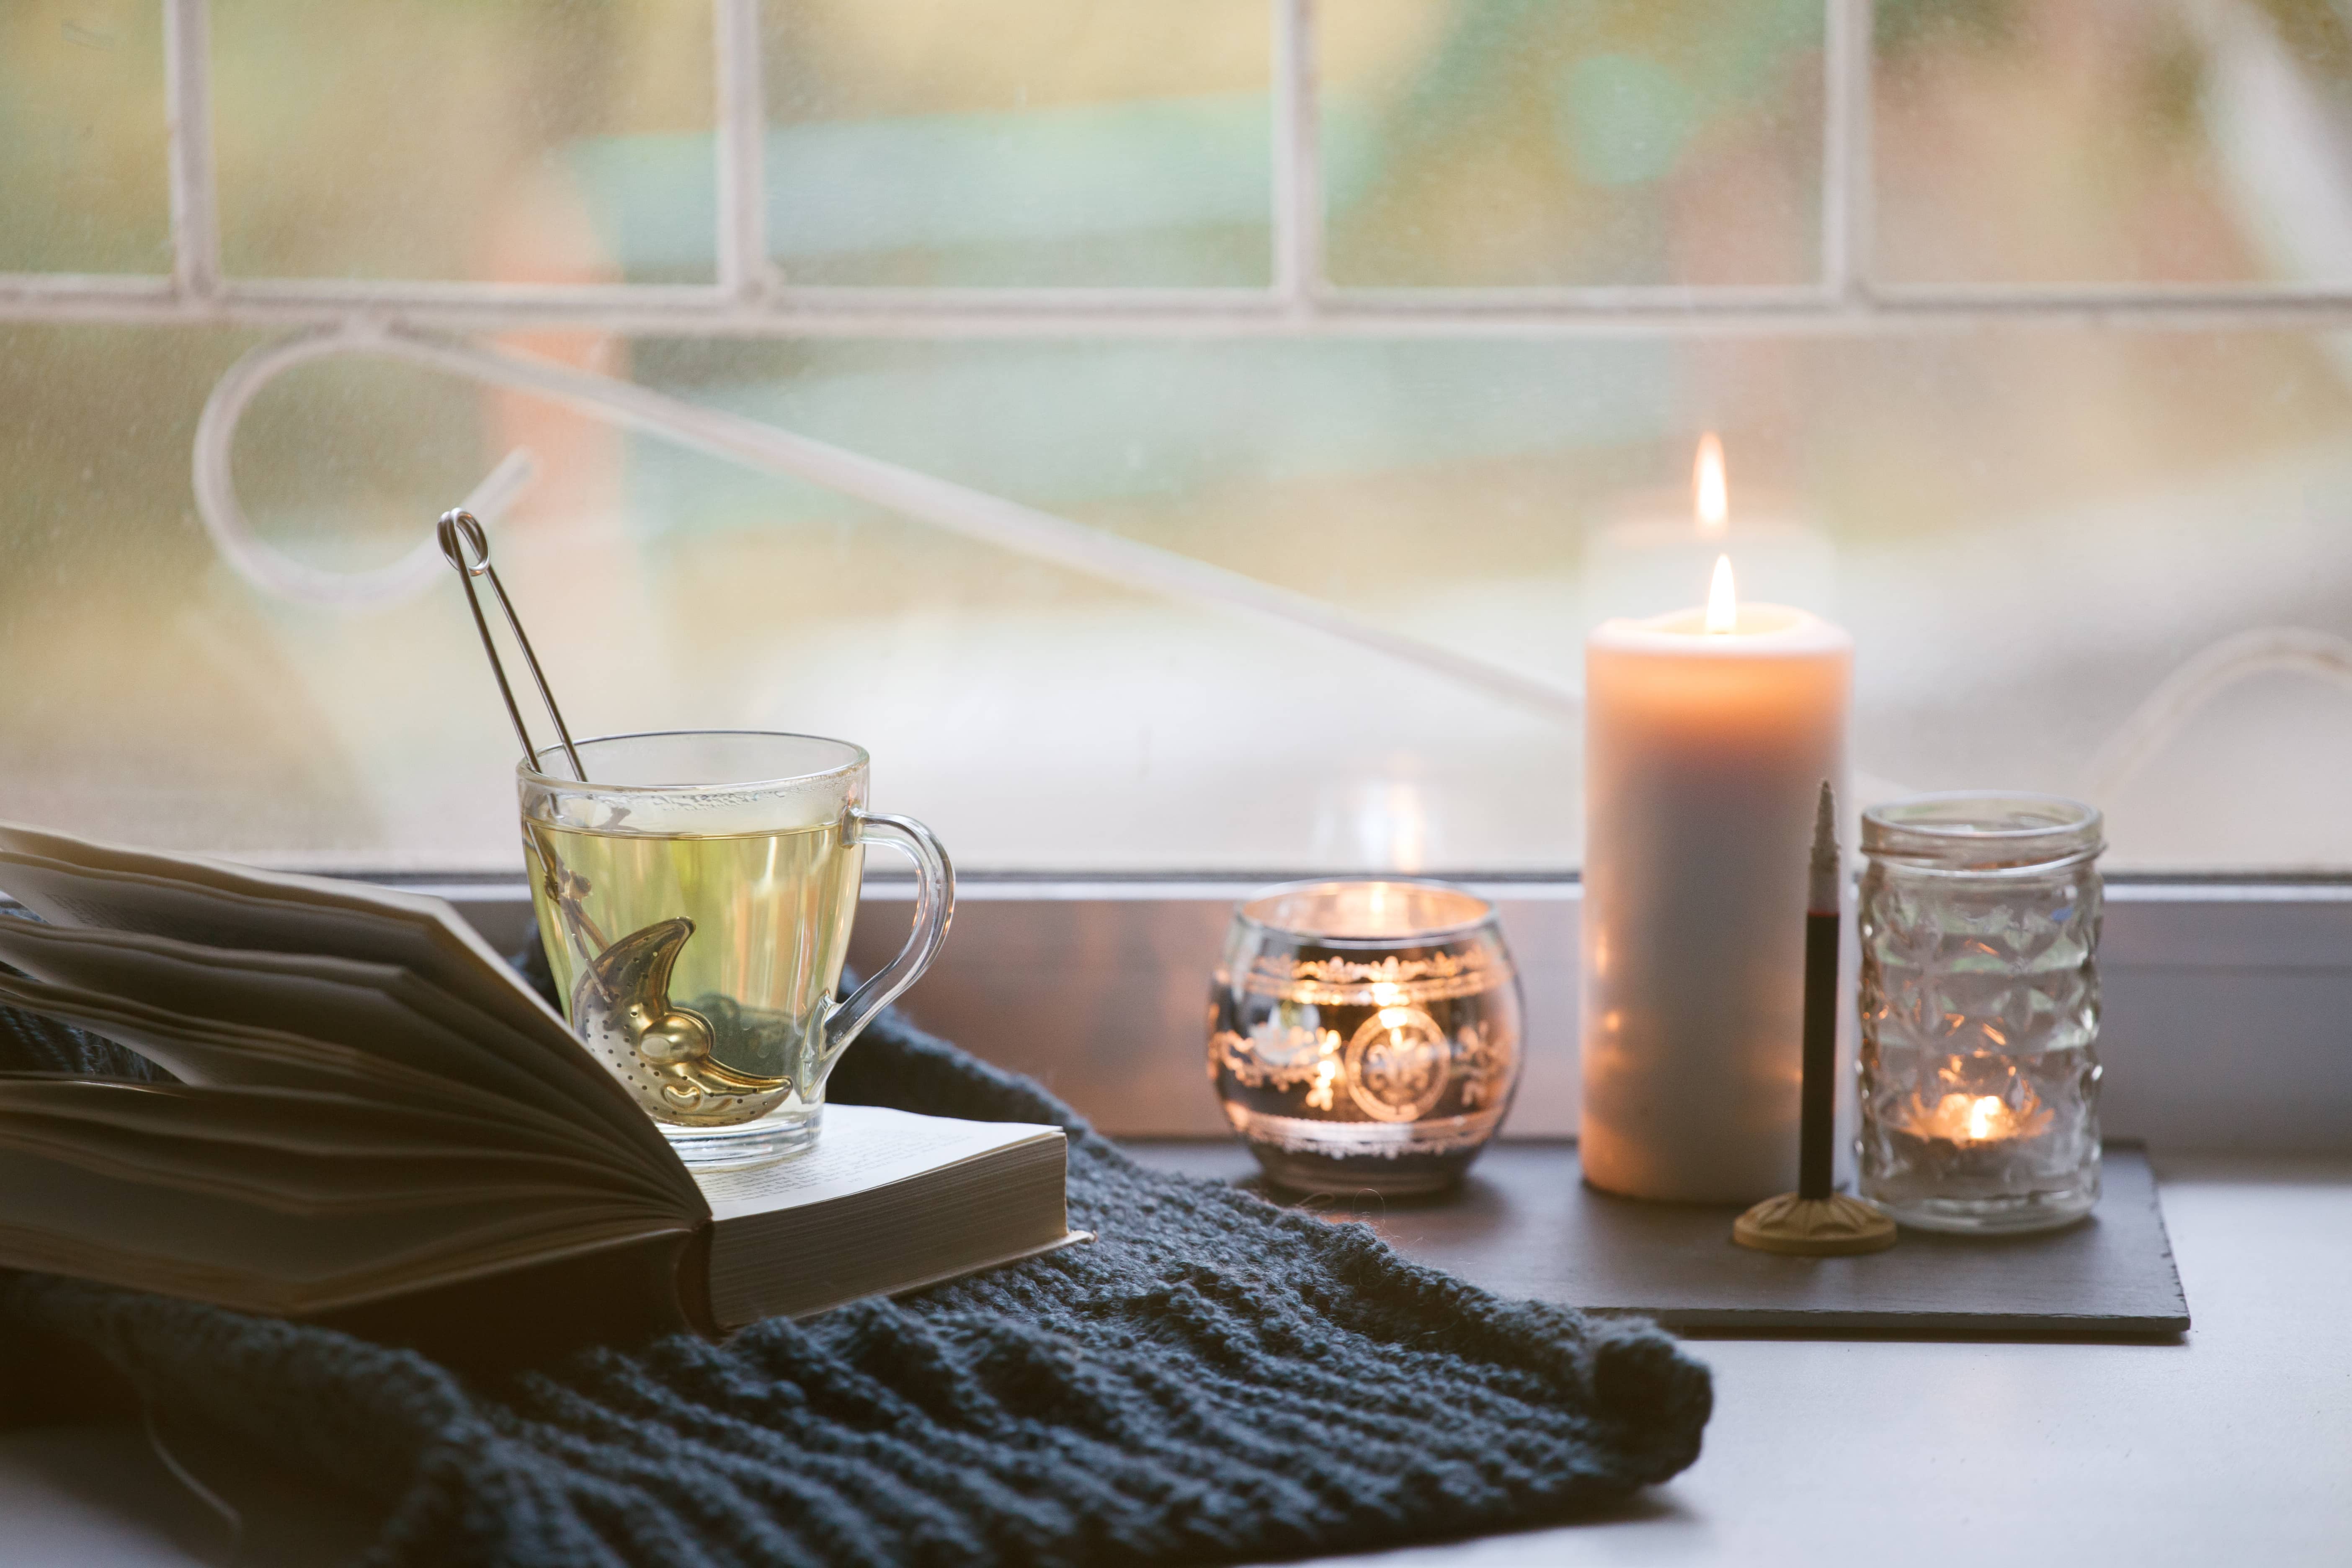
left=0, top=823, right=1077, bottom=1366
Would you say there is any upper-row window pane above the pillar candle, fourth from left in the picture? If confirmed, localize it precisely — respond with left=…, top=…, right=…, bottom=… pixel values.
left=1322, top=0, right=1823, bottom=284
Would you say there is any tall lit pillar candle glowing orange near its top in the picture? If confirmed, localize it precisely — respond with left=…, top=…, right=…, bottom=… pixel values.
left=1581, top=564, right=1853, bottom=1204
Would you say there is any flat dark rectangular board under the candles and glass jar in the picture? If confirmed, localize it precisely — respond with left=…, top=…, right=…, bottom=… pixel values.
left=1127, top=1140, right=2190, bottom=1338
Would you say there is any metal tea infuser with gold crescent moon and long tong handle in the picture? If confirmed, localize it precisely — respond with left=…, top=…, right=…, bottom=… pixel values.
left=435, top=510, right=779, bottom=1114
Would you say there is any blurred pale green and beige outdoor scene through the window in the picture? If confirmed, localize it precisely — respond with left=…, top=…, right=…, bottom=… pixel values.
left=0, top=0, right=2352, bottom=872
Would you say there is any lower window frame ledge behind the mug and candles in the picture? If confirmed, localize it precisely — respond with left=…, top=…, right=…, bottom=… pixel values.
left=9, top=874, right=2352, bottom=1157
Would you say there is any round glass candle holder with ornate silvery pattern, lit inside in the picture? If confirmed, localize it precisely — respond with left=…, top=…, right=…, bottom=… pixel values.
left=1209, top=879, right=1524, bottom=1194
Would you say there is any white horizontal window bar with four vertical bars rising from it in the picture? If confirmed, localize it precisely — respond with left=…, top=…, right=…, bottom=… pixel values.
left=13, top=0, right=2352, bottom=338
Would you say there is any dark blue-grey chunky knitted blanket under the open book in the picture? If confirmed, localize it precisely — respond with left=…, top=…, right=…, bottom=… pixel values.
left=0, top=987, right=1712, bottom=1568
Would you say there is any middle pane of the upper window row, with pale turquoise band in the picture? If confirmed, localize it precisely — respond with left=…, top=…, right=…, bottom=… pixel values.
left=764, top=0, right=1272, bottom=287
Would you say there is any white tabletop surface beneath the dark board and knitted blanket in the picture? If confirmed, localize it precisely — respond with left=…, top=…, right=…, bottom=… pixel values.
left=0, top=1154, right=2352, bottom=1568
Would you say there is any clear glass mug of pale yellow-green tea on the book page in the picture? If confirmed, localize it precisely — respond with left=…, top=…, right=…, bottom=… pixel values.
left=518, top=731, right=955, bottom=1171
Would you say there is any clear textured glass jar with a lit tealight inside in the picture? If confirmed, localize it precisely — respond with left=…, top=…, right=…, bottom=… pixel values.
left=1858, top=794, right=2105, bottom=1234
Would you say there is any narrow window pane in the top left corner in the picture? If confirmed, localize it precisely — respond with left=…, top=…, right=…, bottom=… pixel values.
left=0, top=0, right=172, bottom=273
